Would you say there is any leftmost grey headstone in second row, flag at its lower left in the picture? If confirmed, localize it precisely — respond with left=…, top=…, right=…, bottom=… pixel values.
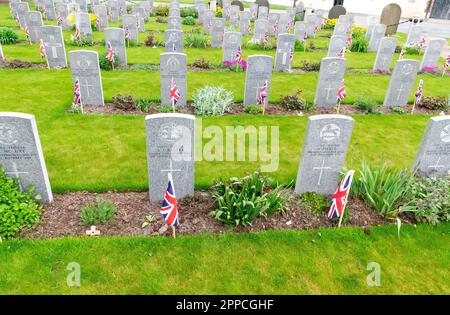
left=69, top=50, right=105, bottom=106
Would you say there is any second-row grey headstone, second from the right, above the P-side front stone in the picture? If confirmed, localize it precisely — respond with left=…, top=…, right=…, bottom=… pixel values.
left=314, top=57, right=347, bottom=107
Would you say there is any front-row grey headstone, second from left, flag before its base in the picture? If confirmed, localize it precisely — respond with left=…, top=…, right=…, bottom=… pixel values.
left=145, top=114, right=195, bottom=202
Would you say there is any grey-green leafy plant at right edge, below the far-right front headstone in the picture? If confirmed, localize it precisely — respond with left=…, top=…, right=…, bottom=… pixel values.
left=400, top=177, right=450, bottom=225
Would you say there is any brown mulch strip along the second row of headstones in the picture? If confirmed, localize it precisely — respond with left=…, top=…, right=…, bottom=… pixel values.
left=84, top=103, right=450, bottom=116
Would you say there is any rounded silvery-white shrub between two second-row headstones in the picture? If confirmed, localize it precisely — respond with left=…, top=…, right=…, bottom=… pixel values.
left=192, top=85, right=233, bottom=115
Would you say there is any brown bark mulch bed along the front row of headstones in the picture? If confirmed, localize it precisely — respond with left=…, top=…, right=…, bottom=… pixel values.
left=21, top=191, right=391, bottom=238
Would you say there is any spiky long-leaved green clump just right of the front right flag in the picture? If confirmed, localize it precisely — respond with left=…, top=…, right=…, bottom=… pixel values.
left=350, top=163, right=412, bottom=217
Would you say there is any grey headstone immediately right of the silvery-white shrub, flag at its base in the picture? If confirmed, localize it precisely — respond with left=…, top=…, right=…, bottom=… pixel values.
left=244, top=55, right=273, bottom=105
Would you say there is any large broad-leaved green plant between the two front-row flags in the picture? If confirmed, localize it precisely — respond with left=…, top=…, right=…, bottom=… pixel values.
left=210, top=172, right=287, bottom=226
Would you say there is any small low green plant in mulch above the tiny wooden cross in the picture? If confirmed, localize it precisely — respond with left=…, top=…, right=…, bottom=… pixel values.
left=80, top=199, right=117, bottom=226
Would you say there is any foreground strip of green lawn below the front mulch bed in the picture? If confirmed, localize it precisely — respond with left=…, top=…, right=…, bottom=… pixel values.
left=0, top=224, right=450, bottom=294
